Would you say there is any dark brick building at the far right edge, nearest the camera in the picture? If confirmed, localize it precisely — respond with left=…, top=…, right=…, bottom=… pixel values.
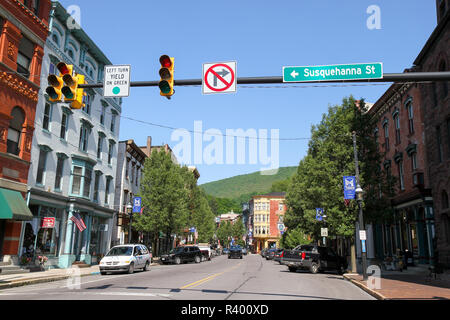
left=413, top=0, right=450, bottom=267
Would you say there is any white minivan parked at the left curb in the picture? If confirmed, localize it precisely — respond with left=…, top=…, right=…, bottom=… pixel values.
left=99, top=244, right=152, bottom=275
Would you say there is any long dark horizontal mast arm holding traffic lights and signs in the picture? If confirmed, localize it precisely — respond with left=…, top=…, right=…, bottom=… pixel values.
left=78, top=71, right=450, bottom=89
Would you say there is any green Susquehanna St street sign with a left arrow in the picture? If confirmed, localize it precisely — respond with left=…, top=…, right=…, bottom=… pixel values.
left=283, top=62, right=383, bottom=82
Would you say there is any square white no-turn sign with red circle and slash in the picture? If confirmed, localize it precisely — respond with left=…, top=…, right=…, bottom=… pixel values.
left=202, top=61, right=237, bottom=94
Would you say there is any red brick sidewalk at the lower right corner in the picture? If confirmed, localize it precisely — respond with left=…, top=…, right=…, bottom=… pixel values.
left=344, top=268, right=450, bottom=300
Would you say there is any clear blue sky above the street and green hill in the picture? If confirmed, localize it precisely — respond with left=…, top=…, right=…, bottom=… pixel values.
left=60, top=0, right=436, bottom=184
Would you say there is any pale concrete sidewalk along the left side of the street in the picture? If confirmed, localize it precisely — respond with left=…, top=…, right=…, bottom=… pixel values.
left=0, top=259, right=159, bottom=290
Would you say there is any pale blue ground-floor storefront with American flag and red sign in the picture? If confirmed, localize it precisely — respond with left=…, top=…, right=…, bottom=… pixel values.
left=21, top=189, right=114, bottom=268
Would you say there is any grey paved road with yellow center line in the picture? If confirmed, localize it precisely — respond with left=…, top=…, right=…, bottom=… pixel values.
left=0, top=255, right=374, bottom=301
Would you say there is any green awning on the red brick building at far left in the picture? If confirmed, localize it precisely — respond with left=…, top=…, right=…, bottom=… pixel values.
left=0, top=188, right=33, bottom=221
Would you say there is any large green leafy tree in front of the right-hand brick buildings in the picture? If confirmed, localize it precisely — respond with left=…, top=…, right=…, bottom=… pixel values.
left=285, top=97, right=389, bottom=239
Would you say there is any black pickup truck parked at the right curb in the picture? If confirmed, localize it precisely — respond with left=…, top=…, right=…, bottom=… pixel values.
left=281, top=245, right=348, bottom=274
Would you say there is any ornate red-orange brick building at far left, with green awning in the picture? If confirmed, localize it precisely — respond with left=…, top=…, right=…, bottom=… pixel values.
left=0, top=0, right=51, bottom=261
